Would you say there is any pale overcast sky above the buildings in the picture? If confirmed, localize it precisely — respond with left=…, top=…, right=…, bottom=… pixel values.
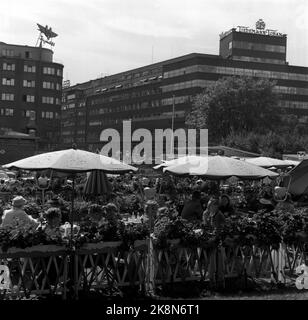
left=0, top=0, right=308, bottom=84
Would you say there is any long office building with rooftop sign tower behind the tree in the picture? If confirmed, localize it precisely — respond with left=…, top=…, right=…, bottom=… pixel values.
left=61, top=20, right=308, bottom=158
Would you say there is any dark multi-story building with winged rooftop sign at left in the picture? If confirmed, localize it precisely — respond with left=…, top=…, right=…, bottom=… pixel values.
left=0, top=42, right=63, bottom=151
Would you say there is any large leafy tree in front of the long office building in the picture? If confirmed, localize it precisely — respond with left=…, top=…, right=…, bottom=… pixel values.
left=186, top=77, right=280, bottom=142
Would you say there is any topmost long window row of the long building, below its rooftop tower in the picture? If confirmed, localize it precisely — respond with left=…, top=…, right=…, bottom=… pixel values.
left=164, top=65, right=308, bottom=81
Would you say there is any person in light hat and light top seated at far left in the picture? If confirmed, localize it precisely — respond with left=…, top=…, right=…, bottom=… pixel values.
left=1, top=196, right=39, bottom=227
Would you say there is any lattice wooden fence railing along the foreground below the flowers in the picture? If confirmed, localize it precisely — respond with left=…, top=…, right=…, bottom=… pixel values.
left=0, top=240, right=306, bottom=299
